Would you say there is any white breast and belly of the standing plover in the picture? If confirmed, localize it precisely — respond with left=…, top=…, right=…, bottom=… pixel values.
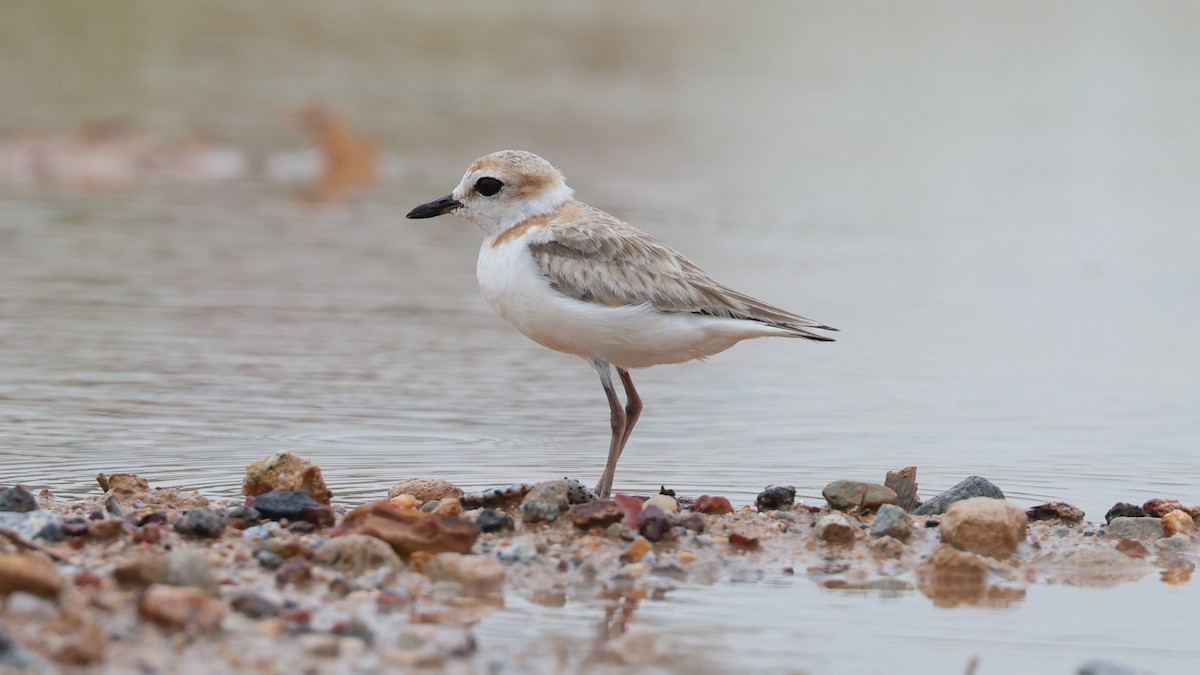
left=475, top=230, right=785, bottom=368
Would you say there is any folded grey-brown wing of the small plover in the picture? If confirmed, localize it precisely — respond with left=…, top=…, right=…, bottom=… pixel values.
left=529, top=200, right=836, bottom=341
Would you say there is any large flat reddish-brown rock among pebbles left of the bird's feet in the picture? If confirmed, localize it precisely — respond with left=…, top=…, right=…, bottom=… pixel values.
left=335, top=500, right=479, bottom=557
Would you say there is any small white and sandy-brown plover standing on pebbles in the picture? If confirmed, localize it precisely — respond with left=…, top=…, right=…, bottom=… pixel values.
left=407, top=150, right=838, bottom=498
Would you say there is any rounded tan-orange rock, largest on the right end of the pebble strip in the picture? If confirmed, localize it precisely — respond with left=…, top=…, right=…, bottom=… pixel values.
left=926, top=497, right=1030, bottom=557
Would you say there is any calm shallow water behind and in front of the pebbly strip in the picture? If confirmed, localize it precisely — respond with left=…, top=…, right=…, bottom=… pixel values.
left=0, top=2, right=1200, bottom=673
